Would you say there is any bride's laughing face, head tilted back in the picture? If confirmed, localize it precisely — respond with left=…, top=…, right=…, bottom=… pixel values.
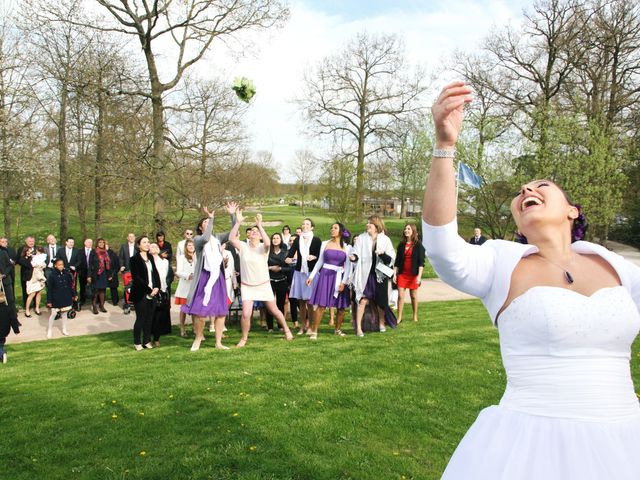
left=511, top=180, right=578, bottom=237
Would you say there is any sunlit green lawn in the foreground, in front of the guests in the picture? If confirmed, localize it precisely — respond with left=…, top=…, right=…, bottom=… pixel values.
left=5, top=301, right=640, bottom=480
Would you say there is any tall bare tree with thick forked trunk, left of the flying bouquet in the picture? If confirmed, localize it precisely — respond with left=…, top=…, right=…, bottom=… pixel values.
left=92, top=0, right=288, bottom=231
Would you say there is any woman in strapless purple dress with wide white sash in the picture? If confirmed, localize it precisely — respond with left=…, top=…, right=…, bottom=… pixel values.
left=307, top=223, right=351, bottom=340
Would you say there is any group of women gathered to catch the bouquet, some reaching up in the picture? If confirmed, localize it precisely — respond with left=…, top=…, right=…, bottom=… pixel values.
left=140, top=203, right=424, bottom=351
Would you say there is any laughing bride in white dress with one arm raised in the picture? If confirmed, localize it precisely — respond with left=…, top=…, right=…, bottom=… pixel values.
left=423, top=82, right=640, bottom=480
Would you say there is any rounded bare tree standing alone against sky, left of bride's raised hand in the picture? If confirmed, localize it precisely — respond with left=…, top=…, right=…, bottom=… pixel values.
left=298, top=33, right=424, bottom=217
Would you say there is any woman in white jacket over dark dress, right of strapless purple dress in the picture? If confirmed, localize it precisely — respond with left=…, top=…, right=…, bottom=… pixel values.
left=350, top=215, right=396, bottom=337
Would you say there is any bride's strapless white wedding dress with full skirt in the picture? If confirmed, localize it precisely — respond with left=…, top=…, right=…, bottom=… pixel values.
left=442, top=286, right=640, bottom=480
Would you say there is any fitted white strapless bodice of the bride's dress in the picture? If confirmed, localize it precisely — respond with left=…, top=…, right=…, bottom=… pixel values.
left=498, top=286, right=640, bottom=421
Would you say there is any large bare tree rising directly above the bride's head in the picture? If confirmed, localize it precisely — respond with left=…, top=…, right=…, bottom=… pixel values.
left=485, top=0, right=589, bottom=176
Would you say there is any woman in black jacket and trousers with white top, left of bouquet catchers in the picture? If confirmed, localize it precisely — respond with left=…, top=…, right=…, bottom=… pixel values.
left=129, top=235, right=160, bottom=351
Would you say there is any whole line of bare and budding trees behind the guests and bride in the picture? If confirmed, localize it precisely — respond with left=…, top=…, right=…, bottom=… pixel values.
left=0, top=0, right=640, bottom=245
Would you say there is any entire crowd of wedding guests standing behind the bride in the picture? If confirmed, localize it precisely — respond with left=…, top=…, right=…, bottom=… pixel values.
left=0, top=203, right=424, bottom=351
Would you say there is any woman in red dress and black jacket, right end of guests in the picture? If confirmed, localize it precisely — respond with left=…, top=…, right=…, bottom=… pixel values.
left=393, top=223, right=424, bottom=323
